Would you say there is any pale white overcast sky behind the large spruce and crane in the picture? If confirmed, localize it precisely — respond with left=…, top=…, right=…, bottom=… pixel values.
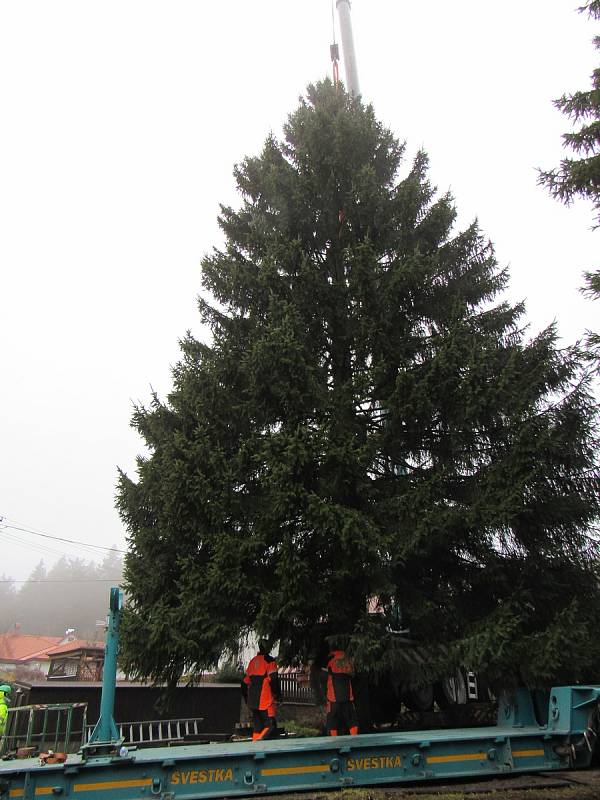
left=0, top=0, right=600, bottom=580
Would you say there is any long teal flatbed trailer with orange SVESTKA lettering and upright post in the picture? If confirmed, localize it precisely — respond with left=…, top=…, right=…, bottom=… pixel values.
left=0, top=589, right=600, bottom=800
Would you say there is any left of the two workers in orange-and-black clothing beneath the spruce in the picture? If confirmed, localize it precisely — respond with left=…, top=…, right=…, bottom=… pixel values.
left=242, top=639, right=281, bottom=742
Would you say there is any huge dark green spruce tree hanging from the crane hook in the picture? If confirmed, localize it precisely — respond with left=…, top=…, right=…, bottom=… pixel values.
left=118, top=81, right=600, bottom=682
